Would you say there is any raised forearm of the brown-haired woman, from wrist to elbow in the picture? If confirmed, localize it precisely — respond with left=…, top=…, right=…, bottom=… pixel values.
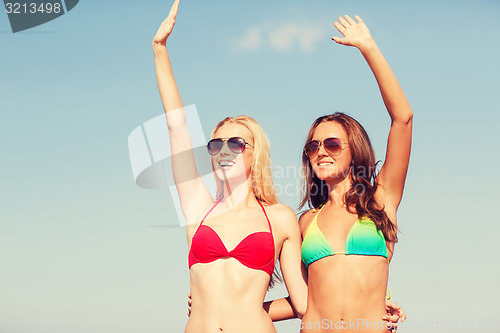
left=359, top=39, right=413, bottom=124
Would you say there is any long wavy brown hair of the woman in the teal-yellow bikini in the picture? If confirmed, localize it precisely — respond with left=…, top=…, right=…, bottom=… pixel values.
left=299, top=112, right=398, bottom=242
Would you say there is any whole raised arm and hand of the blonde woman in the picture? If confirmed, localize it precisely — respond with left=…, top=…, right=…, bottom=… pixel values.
left=153, top=0, right=213, bottom=224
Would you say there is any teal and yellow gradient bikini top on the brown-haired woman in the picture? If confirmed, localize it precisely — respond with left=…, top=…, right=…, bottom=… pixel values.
left=301, top=207, right=387, bottom=267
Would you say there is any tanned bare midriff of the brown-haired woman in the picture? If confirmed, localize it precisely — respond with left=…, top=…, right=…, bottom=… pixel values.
left=301, top=254, right=390, bottom=333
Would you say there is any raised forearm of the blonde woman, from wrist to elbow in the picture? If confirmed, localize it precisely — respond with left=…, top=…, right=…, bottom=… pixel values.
left=153, top=43, right=184, bottom=112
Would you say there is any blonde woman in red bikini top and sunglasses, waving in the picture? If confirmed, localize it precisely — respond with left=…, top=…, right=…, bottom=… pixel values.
left=153, top=0, right=307, bottom=333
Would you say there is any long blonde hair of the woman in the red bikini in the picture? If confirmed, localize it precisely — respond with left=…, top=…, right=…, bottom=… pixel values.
left=210, top=116, right=278, bottom=205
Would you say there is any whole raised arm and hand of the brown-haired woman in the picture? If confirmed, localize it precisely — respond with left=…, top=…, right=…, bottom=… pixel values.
left=332, top=15, right=413, bottom=210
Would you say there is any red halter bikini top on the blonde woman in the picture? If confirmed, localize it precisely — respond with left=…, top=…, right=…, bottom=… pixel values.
left=188, top=200, right=275, bottom=276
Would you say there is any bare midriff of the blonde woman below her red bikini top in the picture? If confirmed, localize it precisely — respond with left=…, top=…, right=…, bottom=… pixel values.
left=185, top=257, right=276, bottom=333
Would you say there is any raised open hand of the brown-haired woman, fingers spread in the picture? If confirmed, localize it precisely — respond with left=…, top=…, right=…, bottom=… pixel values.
left=332, top=15, right=373, bottom=49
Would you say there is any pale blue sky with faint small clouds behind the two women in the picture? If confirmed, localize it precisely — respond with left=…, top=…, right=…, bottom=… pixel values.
left=0, top=0, right=500, bottom=333
